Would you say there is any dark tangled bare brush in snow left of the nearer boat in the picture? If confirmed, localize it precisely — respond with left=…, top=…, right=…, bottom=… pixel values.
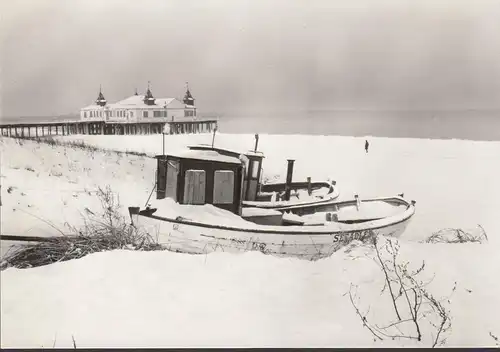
left=0, top=186, right=164, bottom=270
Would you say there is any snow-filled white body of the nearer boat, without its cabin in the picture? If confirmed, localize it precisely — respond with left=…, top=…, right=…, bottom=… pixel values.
left=129, top=192, right=415, bottom=260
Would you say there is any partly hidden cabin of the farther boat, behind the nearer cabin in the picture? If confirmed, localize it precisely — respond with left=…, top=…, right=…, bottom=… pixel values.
left=188, top=144, right=264, bottom=201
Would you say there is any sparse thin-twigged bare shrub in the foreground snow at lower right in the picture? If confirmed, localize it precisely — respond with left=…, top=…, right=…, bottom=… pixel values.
left=349, top=237, right=456, bottom=347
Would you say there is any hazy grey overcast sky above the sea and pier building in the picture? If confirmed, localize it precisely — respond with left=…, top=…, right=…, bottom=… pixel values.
left=0, top=0, right=500, bottom=116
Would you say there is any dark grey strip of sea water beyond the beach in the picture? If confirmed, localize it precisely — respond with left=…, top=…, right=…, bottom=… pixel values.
left=2, top=110, right=500, bottom=141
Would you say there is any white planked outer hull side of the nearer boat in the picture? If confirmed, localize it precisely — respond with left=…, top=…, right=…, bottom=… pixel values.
left=131, top=197, right=415, bottom=260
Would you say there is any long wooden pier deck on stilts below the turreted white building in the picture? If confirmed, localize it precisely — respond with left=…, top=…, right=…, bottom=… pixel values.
left=0, top=120, right=217, bottom=138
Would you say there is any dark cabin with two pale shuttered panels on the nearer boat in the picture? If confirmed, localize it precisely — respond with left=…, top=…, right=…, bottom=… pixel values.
left=156, top=148, right=244, bottom=215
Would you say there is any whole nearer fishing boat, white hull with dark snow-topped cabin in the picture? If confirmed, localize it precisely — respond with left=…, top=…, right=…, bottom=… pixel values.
left=129, top=142, right=415, bottom=260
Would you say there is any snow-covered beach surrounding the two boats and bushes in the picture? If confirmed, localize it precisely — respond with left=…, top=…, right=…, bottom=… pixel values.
left=0, top=134, right=500, bottom=347
